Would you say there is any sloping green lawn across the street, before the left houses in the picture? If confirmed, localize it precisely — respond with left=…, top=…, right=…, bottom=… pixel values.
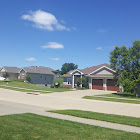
left=0, top=81, right=69, bottom=93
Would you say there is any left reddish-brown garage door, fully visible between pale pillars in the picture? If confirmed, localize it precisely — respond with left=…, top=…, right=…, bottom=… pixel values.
left=92, top=79, right=103, bottom=90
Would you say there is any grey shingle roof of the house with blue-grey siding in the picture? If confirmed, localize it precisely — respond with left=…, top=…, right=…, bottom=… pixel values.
left=23, top=66, right=55, bottom=75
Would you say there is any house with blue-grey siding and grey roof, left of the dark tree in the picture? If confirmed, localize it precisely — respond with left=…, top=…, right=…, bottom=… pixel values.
left=19, top=66, right=57, bottom=86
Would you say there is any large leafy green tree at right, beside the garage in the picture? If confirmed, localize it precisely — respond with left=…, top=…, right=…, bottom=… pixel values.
left=110, top=40, right=140, bottom=95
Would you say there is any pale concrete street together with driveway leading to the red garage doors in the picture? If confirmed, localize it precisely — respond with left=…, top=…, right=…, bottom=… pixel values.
left=0, top=89, right=140, bottom=117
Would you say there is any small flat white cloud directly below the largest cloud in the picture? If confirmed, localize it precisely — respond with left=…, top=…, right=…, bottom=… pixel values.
left=41, top=42, right=64, bottom=49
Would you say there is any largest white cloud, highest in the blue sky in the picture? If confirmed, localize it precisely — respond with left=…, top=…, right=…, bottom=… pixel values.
left=22, top=10, right=70, bottom=31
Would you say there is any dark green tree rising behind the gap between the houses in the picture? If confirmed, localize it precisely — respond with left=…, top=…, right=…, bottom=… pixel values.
left=61, top=63, right=78, bottom=75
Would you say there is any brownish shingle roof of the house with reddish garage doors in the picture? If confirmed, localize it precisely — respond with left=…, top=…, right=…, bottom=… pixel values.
left=63, top=63, right=113, bottom=77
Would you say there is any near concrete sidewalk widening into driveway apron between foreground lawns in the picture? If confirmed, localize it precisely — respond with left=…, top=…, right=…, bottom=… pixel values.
left=0, top=100, right=140, bottom=134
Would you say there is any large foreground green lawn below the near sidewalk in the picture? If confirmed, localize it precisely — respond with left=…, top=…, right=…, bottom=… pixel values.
left=0, top=113, right=140, bottom=140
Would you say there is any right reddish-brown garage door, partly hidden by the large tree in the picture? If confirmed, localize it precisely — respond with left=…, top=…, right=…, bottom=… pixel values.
left=107, top=79, right=119, bottom=91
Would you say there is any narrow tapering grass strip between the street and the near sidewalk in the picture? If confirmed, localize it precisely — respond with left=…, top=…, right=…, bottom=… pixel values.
left=49, top=110, right=140, bottom=127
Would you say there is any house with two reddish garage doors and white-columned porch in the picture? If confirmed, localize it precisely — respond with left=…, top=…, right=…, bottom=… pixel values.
left=63, top=64, right=123, bottom=91
